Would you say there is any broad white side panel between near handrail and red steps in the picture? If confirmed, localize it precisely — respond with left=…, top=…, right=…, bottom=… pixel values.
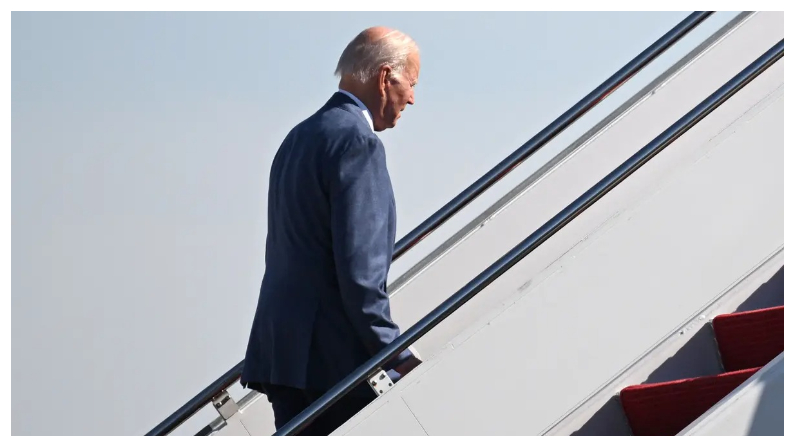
left=336, top=50, right=784, bottom=435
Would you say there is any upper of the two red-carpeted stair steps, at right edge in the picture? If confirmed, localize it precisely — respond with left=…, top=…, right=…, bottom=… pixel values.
left=712, top=306, right=784, bottom=371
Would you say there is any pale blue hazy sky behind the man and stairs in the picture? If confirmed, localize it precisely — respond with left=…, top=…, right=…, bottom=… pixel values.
left=11, top=12, right=735, bottom=435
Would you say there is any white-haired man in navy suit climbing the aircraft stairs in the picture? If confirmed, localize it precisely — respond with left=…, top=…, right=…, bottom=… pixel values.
left=241, top=27, right=420, bottom=435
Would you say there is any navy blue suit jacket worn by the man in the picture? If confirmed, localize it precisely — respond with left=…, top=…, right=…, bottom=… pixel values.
left=241, top=93, right=411, bottom=393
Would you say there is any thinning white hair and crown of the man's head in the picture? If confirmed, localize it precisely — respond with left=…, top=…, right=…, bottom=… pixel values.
left=334, top=31, right=419, bottom=83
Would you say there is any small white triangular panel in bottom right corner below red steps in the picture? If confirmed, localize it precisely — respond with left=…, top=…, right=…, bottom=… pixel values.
left=680, top=352, right=784, bottom=436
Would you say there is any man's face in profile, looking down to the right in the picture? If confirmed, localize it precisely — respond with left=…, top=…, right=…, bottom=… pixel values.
left=374, top=55, right=420, bottom=131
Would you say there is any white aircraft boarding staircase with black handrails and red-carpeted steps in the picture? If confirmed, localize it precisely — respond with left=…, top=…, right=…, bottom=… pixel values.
left=143, top=12, right=783, bottom=436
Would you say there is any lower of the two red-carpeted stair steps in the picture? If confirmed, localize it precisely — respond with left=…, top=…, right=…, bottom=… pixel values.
left=620, top=368, right=761, bottom=436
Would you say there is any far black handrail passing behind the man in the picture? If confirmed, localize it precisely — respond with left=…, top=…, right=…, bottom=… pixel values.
left=146, top=11, right=714, bottom=436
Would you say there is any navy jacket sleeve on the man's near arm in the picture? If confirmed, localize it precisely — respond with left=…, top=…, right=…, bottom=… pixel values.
left=330, top=137, right=412, bottom=370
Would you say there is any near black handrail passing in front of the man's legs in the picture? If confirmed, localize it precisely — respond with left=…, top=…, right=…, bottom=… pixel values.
left=274, top=39, right=784, bottom=436
